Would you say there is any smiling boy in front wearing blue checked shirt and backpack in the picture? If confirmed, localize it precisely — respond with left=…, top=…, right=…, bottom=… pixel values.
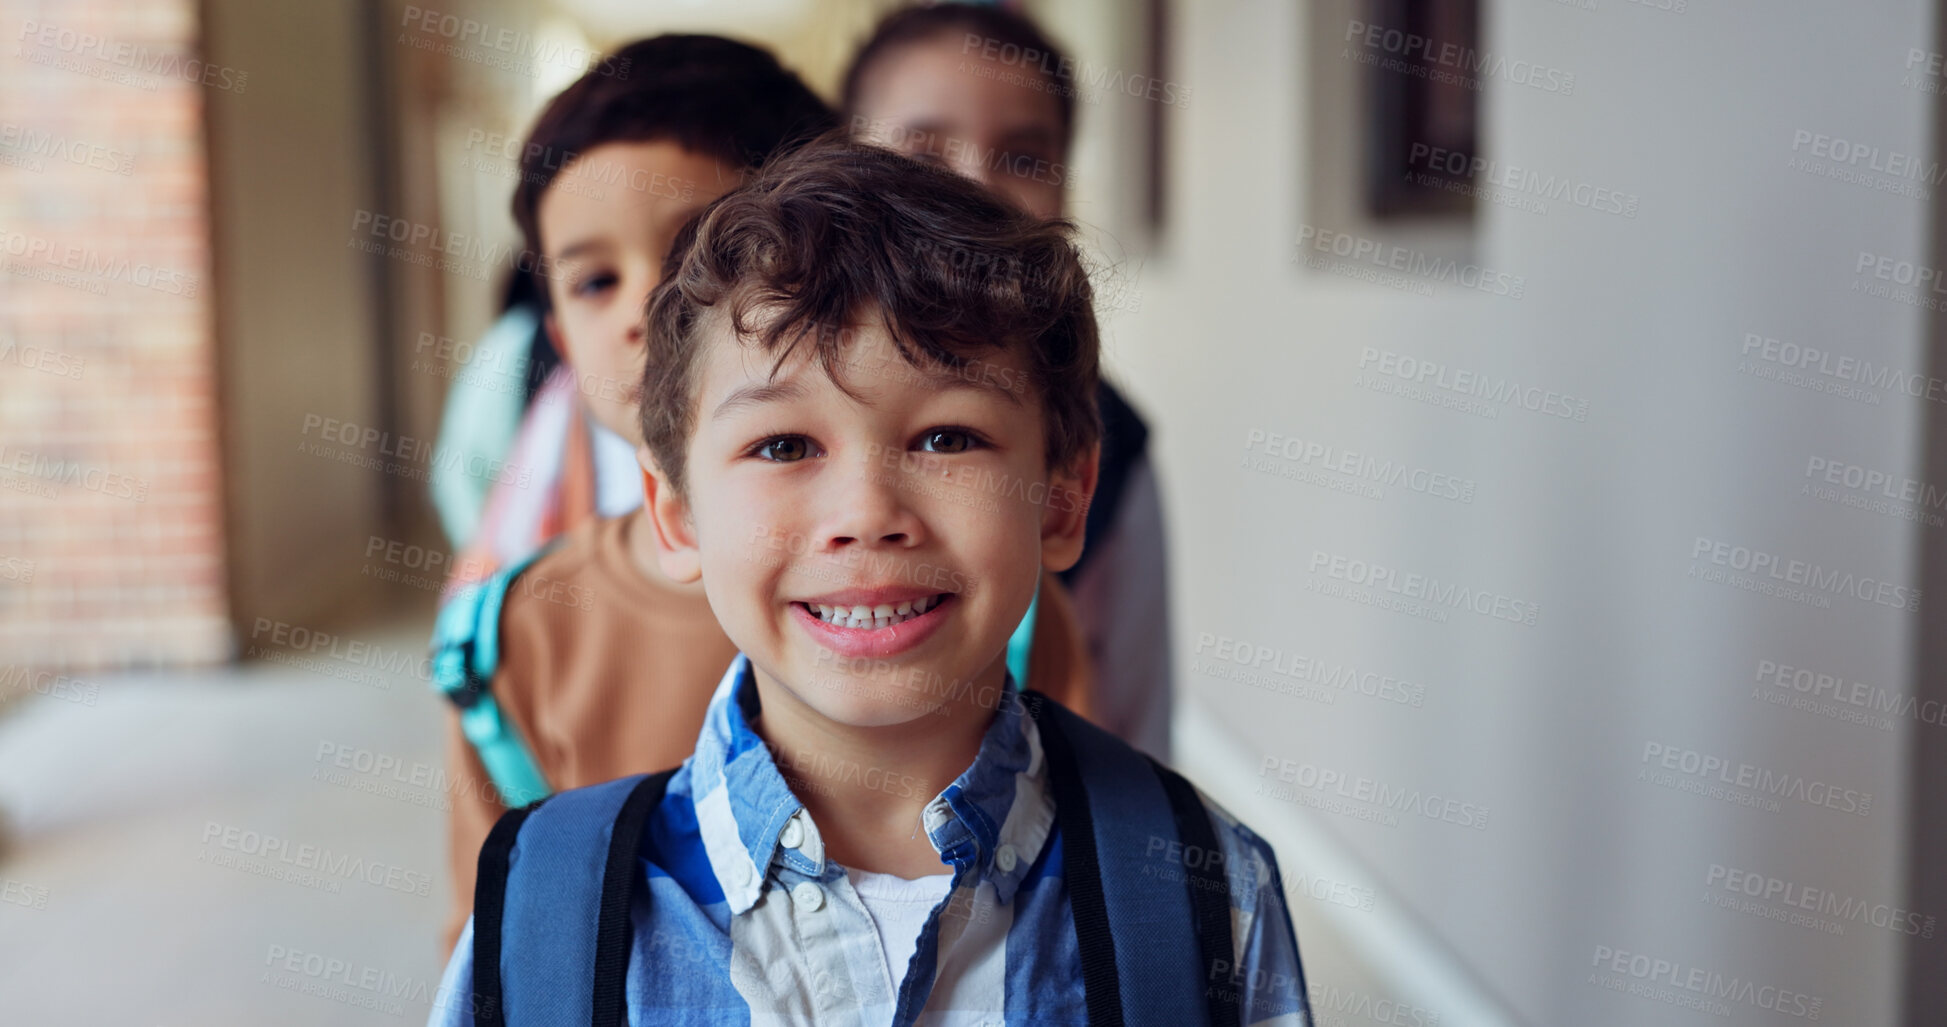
left=434, top=140, right=1306, bottom=1027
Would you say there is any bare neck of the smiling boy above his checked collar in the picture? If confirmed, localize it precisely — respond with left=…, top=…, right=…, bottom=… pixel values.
left=752, top=659, right=1007, bottom=877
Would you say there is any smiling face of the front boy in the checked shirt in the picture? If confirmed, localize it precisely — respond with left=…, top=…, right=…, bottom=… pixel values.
left=650, top=312, right=1096, bottom=727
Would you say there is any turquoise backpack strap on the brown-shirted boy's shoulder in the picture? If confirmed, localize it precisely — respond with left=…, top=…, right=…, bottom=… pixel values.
left=432, top=542, right=555, bottom=807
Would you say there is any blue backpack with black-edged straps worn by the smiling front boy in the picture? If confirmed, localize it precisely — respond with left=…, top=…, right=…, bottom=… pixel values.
left=473, top=690, right=1238, bottom=1027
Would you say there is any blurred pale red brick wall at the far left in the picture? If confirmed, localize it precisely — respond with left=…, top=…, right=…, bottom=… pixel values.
left=0, top=0, right=229, bottom=674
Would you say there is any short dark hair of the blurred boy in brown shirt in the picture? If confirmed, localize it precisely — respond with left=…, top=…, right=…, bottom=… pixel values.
left=514, top=35, right=837, bottom=292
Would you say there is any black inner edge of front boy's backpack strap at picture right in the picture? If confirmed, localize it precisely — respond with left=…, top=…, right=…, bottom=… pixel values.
left=1026, top=692, right=1121, bottom=1027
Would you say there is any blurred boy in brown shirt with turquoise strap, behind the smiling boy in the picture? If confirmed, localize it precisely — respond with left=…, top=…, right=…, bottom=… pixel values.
left=438, top=35, right=1121, bottom=966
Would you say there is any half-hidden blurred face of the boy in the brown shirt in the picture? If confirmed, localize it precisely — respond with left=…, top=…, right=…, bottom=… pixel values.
left=535, top=140, right=738, bottom=442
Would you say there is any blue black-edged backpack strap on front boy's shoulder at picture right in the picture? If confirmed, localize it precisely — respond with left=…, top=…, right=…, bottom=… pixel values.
left=1022, top=690, right=1238, bottom=1027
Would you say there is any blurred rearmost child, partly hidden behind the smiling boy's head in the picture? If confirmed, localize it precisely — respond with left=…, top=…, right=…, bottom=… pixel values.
left=841, top=4, right=1170, bottom=760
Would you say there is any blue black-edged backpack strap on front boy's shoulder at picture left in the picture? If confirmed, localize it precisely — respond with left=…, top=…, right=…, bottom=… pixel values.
left=473, top=770, right=676, bottom=1027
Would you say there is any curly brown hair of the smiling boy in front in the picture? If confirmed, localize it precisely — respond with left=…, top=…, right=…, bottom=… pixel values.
left=643, top=133, right=1102, bottom=495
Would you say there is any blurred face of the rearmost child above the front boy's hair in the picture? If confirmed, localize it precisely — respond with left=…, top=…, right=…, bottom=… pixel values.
left=853, top=31, right=1067, bottom=218
